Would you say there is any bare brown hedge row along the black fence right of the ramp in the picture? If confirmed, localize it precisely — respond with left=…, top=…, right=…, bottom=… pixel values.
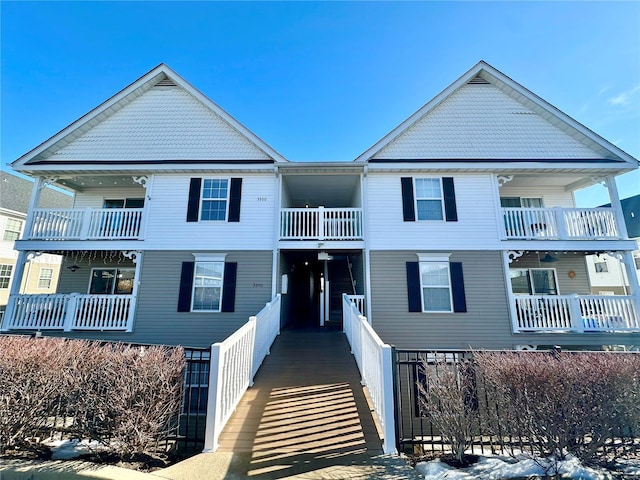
left=418, top=352, right=640, bottom=462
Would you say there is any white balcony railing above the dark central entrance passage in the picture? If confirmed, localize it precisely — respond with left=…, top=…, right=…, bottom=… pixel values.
left=280, top=207, right=362, bottom=240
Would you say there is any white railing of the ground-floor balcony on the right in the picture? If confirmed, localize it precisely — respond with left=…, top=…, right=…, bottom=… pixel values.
left=514, top=295, right=640, bottom=333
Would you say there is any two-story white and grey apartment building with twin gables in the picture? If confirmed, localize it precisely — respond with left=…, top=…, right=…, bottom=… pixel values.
left=3, top=62, right=640, bottom=349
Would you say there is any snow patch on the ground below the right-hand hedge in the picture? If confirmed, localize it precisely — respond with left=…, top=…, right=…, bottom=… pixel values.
left=416, top=456, right=640, bottom=480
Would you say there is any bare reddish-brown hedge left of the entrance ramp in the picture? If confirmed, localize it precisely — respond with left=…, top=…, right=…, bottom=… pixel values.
left=0, top=337, right=185, bottom=457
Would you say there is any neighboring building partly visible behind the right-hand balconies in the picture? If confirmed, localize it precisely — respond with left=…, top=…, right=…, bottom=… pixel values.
left=587, top=195, right=640, bottom=295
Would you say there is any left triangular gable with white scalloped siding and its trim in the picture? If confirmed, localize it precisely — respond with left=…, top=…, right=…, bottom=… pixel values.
left=12, top=64, right=287, bottom=171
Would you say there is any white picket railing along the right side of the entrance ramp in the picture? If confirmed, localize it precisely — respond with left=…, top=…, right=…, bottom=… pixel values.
left=342, top=294, right=397, bottom=453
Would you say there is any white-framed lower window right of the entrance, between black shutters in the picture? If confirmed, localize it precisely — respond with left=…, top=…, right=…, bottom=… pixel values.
left=420, top=259, right=453, bottom=312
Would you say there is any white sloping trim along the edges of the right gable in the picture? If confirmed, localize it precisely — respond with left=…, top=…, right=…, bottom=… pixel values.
left=355, top=61, right=638, bottom=168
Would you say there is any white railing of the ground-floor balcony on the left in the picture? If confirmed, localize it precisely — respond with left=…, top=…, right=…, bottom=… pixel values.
left=2, top=293, right=133, bottom=332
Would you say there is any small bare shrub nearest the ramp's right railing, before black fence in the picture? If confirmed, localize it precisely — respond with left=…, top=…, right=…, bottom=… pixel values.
left=417, top=357, right=478, bottom=463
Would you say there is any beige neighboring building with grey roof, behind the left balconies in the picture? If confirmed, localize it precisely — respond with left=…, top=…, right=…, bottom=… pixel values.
left=0, top=172, right=73, bottom=312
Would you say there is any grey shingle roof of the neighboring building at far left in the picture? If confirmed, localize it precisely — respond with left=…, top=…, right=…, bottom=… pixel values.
left=0, top=171, right=73, bottom=214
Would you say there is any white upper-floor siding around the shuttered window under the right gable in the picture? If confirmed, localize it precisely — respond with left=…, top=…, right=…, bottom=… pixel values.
left=366, top=173, right=499, bottom=250
